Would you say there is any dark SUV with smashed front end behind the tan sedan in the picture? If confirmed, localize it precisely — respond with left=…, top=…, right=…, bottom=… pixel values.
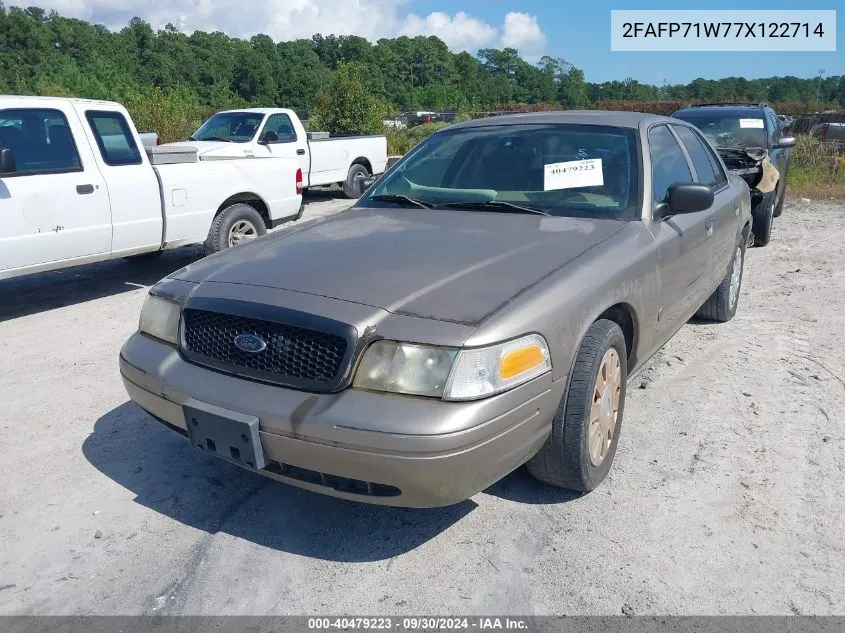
left=672, top=103, right=795, bottom=246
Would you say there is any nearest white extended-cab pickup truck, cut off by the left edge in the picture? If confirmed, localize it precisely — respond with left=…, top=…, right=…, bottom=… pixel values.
left=0, top=96, right=303, bottom=279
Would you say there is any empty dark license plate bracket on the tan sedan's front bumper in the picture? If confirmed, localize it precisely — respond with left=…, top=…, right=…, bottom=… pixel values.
left=182, top=400, right=267, bottom=470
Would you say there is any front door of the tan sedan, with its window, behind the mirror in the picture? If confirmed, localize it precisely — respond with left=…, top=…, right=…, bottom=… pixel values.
left=648, top=124, right=715, bottom=340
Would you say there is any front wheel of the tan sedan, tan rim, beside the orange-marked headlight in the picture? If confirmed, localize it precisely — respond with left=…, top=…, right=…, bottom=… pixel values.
left=528, top=319, right=628, bottom=492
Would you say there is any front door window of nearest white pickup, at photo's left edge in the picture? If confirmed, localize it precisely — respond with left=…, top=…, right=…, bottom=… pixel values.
left=0, top=108, right=82, bottom=177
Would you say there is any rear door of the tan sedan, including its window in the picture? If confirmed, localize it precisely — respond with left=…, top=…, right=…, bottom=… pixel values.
left=672, top=125, right=739, bottom=290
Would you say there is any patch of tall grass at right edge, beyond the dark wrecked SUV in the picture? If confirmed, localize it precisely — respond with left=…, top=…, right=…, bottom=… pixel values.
left=786, top=136, right=845, bottom=199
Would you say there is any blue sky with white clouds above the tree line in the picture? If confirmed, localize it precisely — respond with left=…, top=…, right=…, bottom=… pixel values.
left=13, top=0, right=845, bottom=85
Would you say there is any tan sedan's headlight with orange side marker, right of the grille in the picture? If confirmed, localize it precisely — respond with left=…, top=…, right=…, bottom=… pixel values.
left=354, top=334, right=551, bottom=400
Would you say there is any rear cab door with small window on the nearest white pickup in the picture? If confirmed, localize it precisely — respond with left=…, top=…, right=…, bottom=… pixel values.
left=80, top=105, right=163, bottom=256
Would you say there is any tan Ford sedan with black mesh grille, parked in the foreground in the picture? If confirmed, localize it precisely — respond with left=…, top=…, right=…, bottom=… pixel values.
left=120, top=112, right=751, bottom=507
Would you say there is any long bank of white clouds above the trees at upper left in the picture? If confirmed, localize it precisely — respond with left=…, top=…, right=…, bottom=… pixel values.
left=11, top=0, right=547, bottom=59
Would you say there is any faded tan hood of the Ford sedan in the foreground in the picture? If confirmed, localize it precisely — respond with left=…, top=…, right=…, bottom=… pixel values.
left=171, top=208, right=624, bottom=324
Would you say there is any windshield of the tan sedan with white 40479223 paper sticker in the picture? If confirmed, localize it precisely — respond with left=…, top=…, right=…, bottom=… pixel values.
left=361, top=124, right=639, bottom=219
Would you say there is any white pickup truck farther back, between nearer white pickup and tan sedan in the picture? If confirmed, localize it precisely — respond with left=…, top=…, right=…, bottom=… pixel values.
left=186, top=108, right=387, bottom=198
